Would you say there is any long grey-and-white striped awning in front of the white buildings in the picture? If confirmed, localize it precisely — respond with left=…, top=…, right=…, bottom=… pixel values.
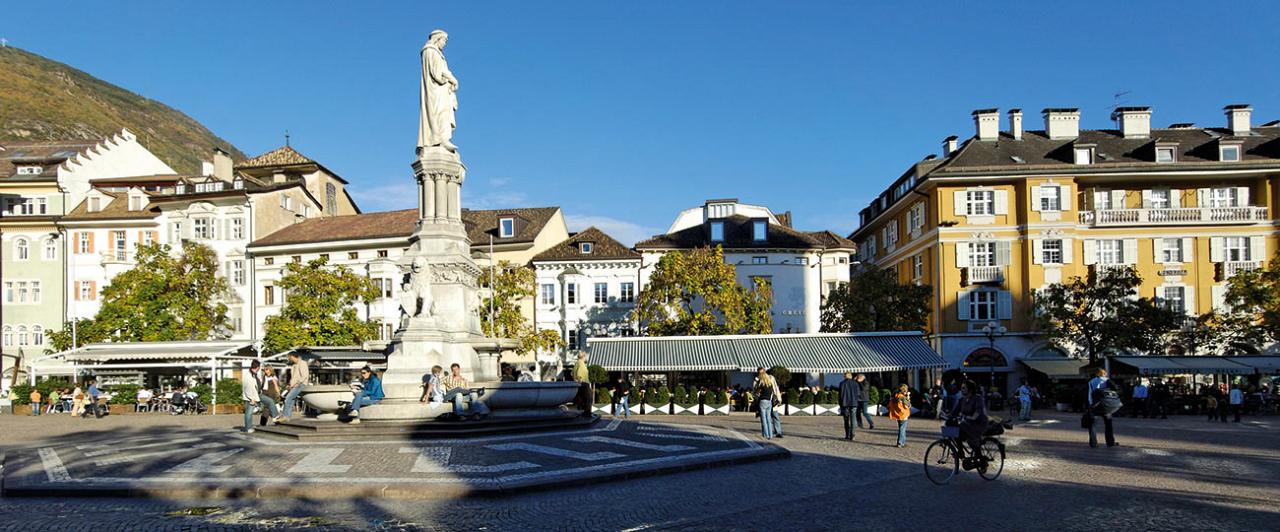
left=589, top=333, right=947, bottom=373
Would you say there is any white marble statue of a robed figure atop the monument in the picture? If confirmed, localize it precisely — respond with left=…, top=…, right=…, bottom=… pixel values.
left=417, top=29, right=458, bottom=152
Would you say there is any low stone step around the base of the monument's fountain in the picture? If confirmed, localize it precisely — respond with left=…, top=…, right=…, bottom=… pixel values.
left=257, top=414, right=600, bottom=441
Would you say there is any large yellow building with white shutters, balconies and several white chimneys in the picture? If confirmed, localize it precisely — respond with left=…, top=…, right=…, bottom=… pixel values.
left=851, top=105, right=1280, bottom=389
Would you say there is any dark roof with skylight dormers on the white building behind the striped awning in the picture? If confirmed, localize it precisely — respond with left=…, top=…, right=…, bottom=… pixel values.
left=636, top=215, right=838, bottom=249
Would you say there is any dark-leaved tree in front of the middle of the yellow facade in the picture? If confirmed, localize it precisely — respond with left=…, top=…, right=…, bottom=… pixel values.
left=1034, top=267, right=1185, bottom=362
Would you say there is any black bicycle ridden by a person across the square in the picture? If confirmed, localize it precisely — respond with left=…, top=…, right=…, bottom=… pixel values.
left=924, top=418, right=1012, bottom=486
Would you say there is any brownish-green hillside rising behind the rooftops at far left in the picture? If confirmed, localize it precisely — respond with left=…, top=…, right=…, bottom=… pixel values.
left=0, top=46, right=244, bottom=174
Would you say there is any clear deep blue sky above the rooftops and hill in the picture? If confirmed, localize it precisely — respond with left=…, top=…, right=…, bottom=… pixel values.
left=0, top=0, right=1280, bottom=242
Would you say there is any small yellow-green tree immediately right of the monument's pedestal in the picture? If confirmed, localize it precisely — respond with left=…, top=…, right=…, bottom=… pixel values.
left=479, top=261, right=564, bottom=354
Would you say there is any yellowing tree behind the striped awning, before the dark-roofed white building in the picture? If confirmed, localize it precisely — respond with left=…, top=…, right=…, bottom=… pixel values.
left=632, top=246, right=773, bottom=336
